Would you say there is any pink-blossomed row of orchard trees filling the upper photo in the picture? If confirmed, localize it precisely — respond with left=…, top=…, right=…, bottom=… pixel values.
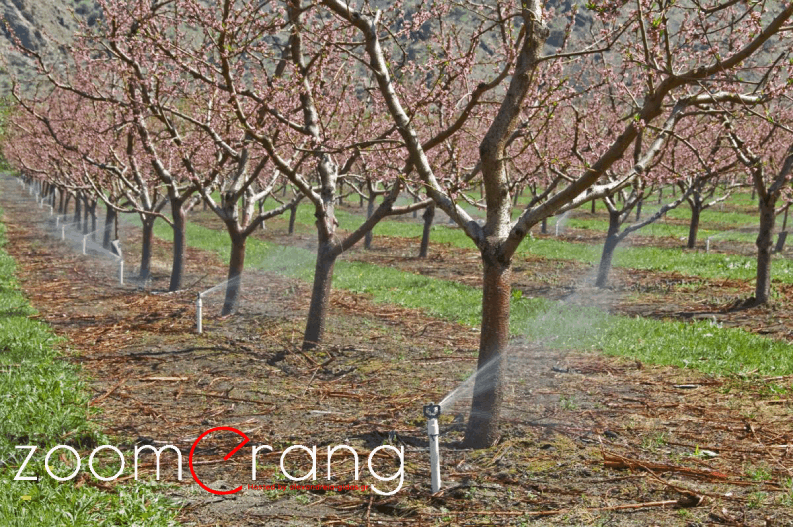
left=3, top=0, right=793, bottom=447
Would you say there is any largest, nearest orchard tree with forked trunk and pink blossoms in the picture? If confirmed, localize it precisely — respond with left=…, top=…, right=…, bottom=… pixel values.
left=322, top=0, right=793, bottom=447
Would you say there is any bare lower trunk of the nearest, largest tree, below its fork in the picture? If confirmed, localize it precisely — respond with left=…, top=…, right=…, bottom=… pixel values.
left=464, top=255, right=512, bottom=448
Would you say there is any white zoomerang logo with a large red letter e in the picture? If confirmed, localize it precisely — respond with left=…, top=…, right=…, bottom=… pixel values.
left=14, top=426, right=405, bottom=496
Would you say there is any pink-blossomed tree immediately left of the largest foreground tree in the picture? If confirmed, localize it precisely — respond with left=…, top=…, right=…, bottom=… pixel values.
left=132, top=0, right=429, bottom=349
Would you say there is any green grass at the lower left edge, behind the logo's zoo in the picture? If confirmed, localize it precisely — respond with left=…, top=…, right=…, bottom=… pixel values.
left=0, top=209, right=176, bottom=527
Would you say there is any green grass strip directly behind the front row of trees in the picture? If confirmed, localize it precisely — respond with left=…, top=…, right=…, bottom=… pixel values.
left=148, top=222, right=793, bottom=375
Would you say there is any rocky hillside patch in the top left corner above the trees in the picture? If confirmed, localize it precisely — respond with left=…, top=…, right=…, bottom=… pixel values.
left=0, top=0, right=99, bottom=95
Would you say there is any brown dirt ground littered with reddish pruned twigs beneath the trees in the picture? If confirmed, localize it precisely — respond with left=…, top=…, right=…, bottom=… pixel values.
left=0, top=180, right=793, bottom=526
